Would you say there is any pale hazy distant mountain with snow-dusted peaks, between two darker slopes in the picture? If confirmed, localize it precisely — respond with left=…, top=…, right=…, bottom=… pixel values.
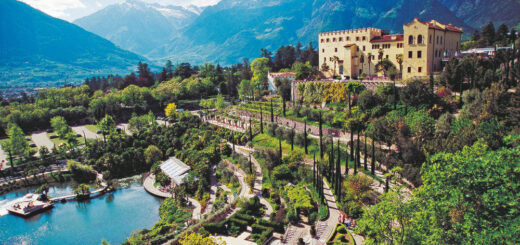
left=74, top=0, right=202, bottom=55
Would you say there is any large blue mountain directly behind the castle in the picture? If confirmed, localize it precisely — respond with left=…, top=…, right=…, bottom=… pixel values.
left=148, top=0, right=471, bottom=64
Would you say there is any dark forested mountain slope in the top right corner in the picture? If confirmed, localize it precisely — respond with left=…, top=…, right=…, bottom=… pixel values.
left=439, top=0, right=520, bottom=29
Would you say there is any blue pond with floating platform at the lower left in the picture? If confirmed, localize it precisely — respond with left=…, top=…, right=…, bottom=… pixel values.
left=0, top=178, right=162, bottom=244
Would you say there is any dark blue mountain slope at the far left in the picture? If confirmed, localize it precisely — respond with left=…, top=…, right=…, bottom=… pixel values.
left=0, top=0, right=142, bottom=88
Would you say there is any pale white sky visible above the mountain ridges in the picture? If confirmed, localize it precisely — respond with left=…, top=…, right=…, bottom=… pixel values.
left=20, top=0, right=220, bottom=22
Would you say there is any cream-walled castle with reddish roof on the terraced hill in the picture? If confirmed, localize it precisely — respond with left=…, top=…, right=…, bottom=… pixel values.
left=318, top=18, right=462, bottom=80
